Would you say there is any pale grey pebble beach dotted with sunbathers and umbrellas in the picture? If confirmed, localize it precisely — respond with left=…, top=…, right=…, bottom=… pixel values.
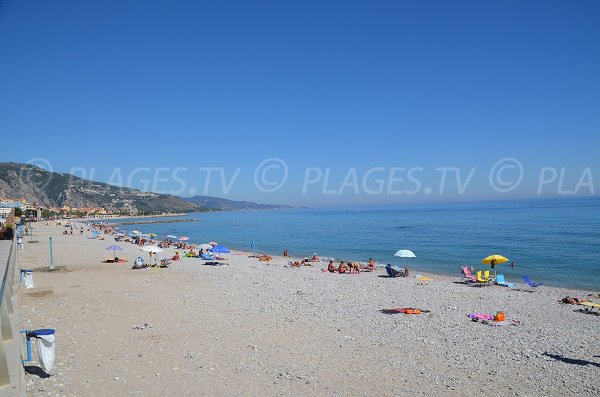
left=17, top=224, right=600, bottom=397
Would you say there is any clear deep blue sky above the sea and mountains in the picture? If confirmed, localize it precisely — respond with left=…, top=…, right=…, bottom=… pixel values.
left=0, top=0, right=600, bottom=206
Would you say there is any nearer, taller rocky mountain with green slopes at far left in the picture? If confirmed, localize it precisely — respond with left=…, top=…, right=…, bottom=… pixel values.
left=0, top=163, right=206, bottom=214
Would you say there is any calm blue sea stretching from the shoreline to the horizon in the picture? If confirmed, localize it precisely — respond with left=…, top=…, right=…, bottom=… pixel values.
left=104, top=198, right=600, bottom=291
